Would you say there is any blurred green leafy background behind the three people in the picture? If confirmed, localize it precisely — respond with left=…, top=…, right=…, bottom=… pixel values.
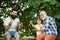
left=0, top=0, right=60, bottom=40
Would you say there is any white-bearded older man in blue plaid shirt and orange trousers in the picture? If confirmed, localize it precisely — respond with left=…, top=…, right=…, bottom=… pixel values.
left=39, top=11, right=57, bottom=40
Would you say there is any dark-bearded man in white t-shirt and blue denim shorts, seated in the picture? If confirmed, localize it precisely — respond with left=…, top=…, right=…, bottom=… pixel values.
left=4, top=9, right=20, bottom=40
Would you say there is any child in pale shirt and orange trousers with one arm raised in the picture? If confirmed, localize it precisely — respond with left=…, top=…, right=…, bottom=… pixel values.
left=30, top=18, right=44, bottom=40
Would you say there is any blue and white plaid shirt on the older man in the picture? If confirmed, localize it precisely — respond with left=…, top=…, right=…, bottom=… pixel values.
left=43, top=16, right=57, bottom=35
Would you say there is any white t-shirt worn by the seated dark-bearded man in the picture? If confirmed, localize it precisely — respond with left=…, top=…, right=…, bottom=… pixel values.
left=4, top=17, right=19, bottom=31
